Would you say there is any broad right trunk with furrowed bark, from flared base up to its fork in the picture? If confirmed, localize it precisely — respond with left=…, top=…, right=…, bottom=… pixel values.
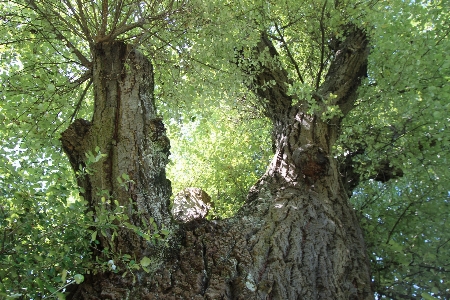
left=66, top=34, right=373, bottom=299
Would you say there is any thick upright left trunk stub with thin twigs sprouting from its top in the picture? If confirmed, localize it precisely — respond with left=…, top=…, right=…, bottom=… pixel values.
left=61, top=42, right=175, bottom=257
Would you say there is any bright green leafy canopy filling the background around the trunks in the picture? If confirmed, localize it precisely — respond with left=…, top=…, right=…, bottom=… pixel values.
left=0, top=0, right=450, bottom=299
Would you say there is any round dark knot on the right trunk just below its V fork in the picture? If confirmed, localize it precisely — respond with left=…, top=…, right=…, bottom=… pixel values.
left=292, top=144, right=329, bottom=180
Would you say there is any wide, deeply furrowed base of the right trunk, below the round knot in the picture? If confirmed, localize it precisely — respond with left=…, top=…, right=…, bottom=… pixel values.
left=71, top=176, right=373, bottom=299
